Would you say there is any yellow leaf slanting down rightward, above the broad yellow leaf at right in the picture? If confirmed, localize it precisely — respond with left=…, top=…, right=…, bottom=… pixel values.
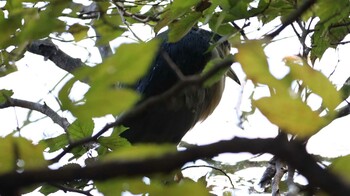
left=284, top=56, right=342, bottom=112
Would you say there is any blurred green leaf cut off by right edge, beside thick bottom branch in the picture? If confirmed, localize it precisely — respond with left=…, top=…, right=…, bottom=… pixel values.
left=329, top=155, right=350, bottom=184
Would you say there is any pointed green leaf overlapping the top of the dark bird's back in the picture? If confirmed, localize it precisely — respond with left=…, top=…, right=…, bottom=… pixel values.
left=168, top=12, right=202, bottom=43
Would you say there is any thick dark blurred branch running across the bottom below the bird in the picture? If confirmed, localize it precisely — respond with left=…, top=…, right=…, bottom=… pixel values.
left=0, top=138, right=350, bottom=195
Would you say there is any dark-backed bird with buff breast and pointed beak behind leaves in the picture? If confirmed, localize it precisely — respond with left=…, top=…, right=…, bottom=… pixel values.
left=121, top=28, right=239, bottom=143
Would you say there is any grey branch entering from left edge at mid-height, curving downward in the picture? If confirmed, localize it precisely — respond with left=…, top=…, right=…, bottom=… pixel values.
left=0, top=98, right=70, bottom=130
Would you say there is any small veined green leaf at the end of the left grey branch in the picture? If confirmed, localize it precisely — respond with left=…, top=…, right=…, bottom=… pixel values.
left=68, top=119, right=94, bottom=141
